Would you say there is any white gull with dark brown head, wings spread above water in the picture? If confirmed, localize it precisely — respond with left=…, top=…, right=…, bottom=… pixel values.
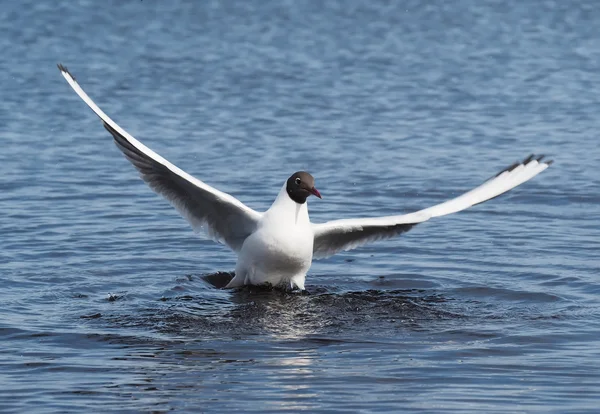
left=58, top=64, right=552, bottom=290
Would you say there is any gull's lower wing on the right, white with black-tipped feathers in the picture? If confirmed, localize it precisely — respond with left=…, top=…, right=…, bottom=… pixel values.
left=313, top=155, right=552, bottom=258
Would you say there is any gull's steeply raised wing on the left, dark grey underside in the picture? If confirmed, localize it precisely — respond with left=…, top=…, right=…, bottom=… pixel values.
left=58, top=65, right=262, bottom=251
